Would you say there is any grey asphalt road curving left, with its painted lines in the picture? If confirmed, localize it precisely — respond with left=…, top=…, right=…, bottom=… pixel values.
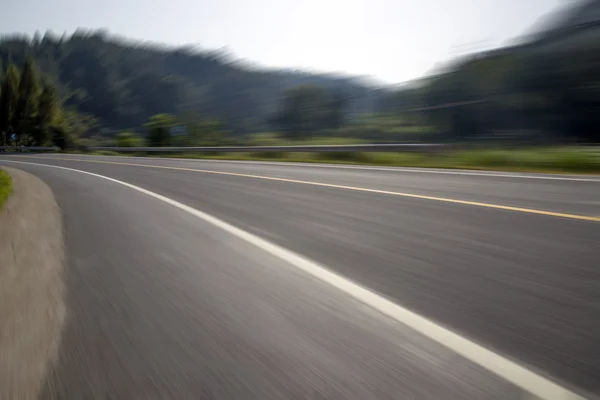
left=0, top=155, right=600, bottom=399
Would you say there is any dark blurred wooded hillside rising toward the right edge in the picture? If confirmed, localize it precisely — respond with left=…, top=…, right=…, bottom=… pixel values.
left=382, top=9, right=600, bottom=143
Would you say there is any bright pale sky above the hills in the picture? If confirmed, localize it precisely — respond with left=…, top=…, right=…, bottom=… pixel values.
left=0, top=0, right=565, bottom=83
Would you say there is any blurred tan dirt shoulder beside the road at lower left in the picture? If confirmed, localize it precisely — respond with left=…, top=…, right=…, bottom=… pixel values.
left=0, top=168, right=66, bottom=399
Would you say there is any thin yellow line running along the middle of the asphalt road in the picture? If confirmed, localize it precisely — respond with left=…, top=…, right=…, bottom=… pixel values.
left=9, top=156, right=600, bottom=222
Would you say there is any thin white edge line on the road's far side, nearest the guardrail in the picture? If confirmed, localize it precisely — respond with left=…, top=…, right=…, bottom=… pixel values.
left=23, top=154, right=600, bottom=183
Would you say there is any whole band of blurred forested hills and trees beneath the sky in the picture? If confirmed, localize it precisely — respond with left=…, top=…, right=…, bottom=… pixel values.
left=0, top=16, right=600, bottom=147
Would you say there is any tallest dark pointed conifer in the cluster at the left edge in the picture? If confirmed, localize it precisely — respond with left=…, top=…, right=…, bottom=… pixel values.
left=14, top=57, right=39, bottom=145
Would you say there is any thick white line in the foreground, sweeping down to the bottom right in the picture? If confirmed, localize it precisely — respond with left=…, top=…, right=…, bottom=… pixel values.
left=0, top=159, right=584, bottom=400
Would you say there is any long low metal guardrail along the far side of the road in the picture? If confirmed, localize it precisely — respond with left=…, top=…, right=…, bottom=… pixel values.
left=87, top=143, right=446, bottom=153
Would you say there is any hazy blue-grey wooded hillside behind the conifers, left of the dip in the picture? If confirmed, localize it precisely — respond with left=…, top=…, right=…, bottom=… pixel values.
left=0, top=30, right=378, bottom=133
